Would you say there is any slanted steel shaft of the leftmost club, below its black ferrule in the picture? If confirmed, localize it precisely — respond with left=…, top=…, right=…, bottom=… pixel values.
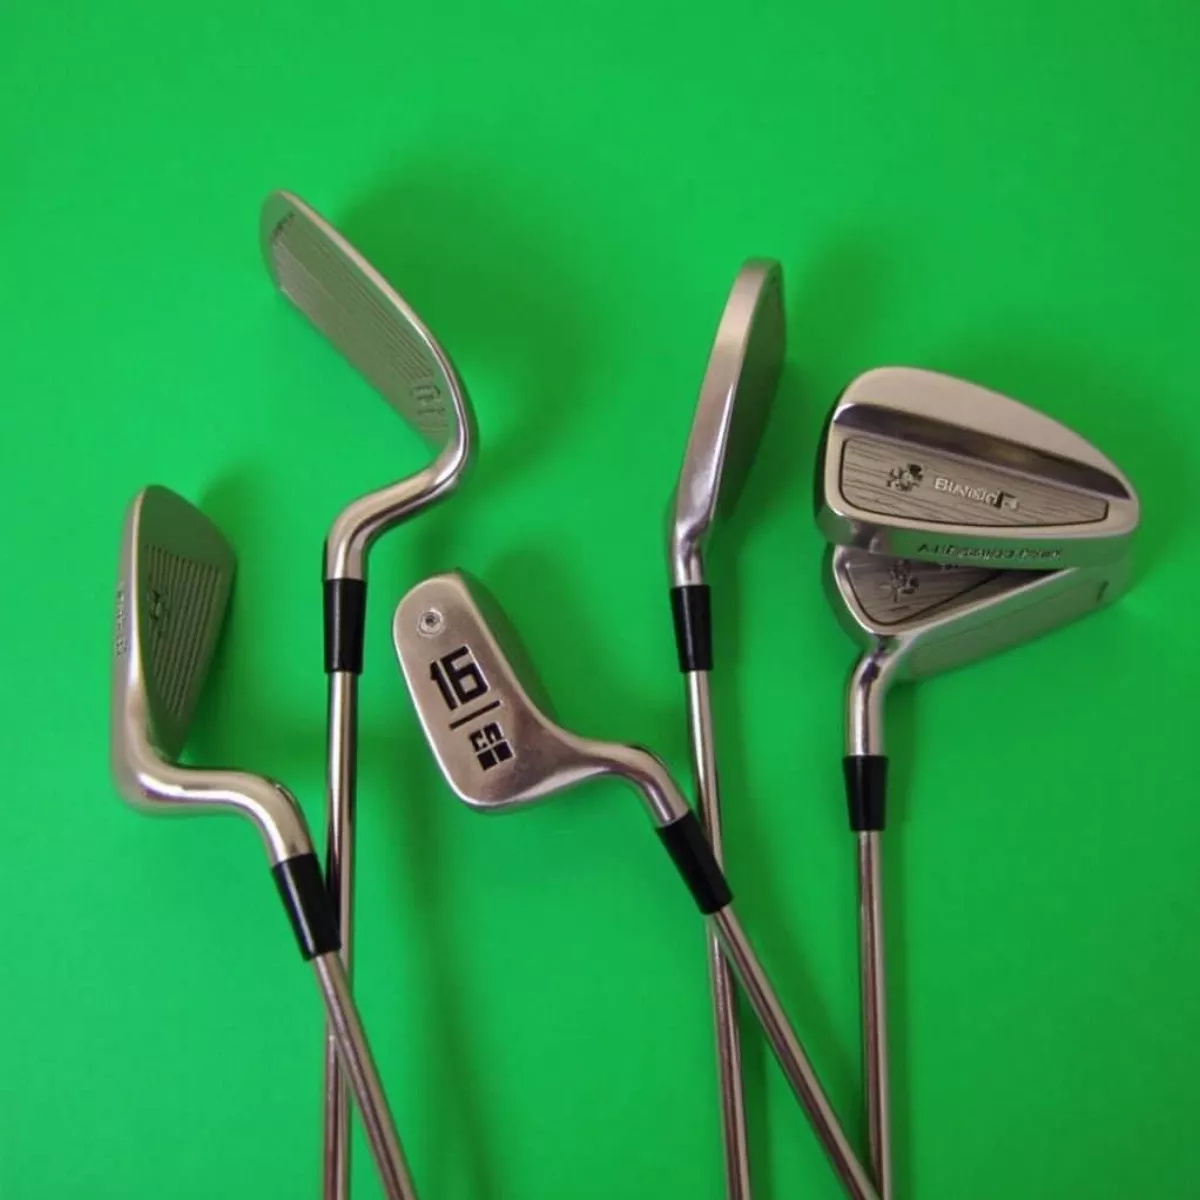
left=312, top=954, right=416, bottom=1200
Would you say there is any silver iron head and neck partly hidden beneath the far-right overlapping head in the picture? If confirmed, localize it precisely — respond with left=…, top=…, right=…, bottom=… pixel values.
left=824, top=546, right=1129, bottom=755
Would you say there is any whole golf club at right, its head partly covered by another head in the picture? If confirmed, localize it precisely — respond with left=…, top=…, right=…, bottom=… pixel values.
left=826, top=546, right=1129, bottom=1200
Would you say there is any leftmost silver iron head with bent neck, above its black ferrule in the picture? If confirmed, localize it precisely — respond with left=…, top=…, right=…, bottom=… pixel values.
left=109, top=487, right=311, bottom=863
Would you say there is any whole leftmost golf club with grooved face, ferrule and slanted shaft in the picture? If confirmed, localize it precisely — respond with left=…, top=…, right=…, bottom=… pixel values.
left=110, top=487, right=416, bottom=1200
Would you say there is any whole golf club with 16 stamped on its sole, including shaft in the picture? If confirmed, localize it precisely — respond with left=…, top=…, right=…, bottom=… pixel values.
left=392, top=574, right=876, bottom=1200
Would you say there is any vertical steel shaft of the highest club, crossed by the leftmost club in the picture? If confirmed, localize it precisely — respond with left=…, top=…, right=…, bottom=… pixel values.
left=322, top=671, right=359, bottom=1200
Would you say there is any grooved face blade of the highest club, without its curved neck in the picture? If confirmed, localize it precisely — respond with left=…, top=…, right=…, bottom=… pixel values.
left=260, top=192, right=470, bottom=445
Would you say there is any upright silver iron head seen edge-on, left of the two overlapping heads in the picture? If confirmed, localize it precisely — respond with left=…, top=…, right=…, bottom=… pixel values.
left=668, top=259, right=787, bottom=587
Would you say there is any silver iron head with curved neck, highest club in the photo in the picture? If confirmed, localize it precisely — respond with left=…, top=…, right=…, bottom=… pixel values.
left=259, top=191, right=476, bottom=578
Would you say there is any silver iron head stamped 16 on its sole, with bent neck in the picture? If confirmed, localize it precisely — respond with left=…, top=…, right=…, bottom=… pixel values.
left=392, top=572, right=689, bottom=826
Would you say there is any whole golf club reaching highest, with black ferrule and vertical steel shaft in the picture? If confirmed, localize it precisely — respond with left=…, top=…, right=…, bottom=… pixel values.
left=262, top=192, right=475, bottom=1200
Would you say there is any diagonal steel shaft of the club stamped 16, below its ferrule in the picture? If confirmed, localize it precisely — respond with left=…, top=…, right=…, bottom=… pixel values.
left=708, top=905, right=880, bottom=1200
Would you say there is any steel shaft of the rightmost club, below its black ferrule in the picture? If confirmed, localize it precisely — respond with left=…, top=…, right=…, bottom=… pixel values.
left=858, top=830, right=892, bottom=1200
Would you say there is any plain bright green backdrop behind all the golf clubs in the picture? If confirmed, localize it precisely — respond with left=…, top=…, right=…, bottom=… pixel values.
left=0, top=0, right=1200, bottom=1200
